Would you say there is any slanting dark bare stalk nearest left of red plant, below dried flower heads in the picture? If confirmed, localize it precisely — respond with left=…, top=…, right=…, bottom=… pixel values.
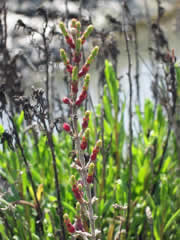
left=42, top=119, right=66, bottom=240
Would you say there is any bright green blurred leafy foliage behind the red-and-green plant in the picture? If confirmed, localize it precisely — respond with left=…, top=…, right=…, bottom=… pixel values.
left=0, top=61, right=180, bottom=240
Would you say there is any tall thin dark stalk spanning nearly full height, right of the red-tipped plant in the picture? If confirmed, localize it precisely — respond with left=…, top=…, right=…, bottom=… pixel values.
left=123, top=3, right=133, bottom=239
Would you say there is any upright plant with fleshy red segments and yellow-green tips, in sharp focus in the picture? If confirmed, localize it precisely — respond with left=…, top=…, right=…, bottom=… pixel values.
left=60, top=19, right=102, bottom=240
